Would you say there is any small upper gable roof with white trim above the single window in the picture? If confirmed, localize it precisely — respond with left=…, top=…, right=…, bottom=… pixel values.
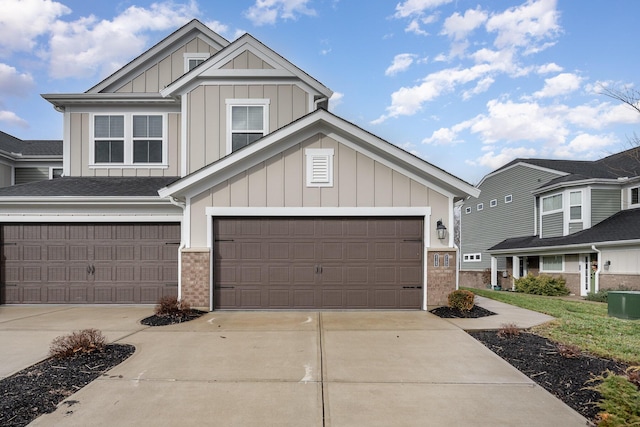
left=160, top=33, right=333, bottom=98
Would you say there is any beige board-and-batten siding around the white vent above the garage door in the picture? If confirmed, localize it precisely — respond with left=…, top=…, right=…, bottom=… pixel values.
left=190, top=134, right=449, bottom=247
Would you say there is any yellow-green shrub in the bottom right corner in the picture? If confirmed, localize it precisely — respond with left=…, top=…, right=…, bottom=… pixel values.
left=589, top=366, right=640, bottom=427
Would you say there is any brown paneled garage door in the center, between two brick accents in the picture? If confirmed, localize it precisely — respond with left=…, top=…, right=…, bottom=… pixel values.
left=213, top=218, right=423, bottom=309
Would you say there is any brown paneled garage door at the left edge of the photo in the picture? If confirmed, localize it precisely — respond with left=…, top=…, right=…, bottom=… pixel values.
left=0, top=223, right=180, bottom=304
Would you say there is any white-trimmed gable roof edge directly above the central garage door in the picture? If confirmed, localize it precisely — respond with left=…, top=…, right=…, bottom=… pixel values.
left=158, top=109, right=480, bottom=201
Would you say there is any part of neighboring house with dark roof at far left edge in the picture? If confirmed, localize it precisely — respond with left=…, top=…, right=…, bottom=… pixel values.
left=0, top=131, right=62, bottom=187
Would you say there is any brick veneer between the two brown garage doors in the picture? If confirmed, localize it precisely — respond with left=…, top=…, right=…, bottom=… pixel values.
left=181, top=249, right=211, bottom=310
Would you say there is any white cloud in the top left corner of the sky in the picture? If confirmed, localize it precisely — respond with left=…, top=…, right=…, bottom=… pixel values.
left=0, top=0, right=71, bottom=55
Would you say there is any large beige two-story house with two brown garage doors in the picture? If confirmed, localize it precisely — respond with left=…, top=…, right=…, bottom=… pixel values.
left=0, top=20, right=479, bottom=310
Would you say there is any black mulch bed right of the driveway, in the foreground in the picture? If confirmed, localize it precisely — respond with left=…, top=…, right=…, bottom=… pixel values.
left=470, top=331, right=627, bottom=421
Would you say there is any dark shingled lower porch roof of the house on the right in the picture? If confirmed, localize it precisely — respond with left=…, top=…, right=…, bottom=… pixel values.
left=488, top=208, right=640, bottom=253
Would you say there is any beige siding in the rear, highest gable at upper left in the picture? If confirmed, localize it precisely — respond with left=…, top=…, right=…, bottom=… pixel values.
left=115, top=37, right=217, bottom=93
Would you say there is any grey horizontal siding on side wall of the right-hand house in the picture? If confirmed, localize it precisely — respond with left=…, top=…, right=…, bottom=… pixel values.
left=460, top=165, right=559, bottom=270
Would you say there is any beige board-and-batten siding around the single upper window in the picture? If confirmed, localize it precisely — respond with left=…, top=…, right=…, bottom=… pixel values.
left=187, top=84, right=309, bottom=173
